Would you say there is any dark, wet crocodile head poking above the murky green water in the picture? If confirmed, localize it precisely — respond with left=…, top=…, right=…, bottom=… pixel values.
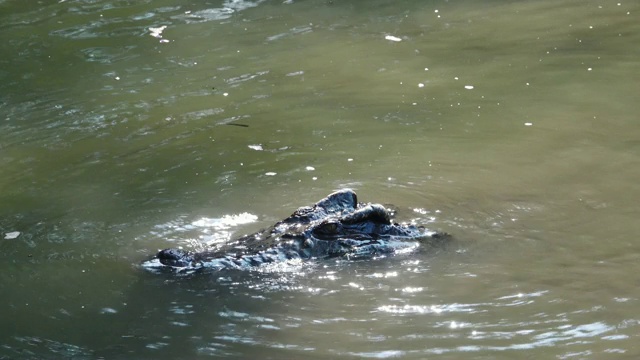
left=156, top=189, right=448, bottom=270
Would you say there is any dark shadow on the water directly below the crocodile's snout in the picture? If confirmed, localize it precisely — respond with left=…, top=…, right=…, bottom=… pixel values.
left=96, top=271, right=298, bottom=359
